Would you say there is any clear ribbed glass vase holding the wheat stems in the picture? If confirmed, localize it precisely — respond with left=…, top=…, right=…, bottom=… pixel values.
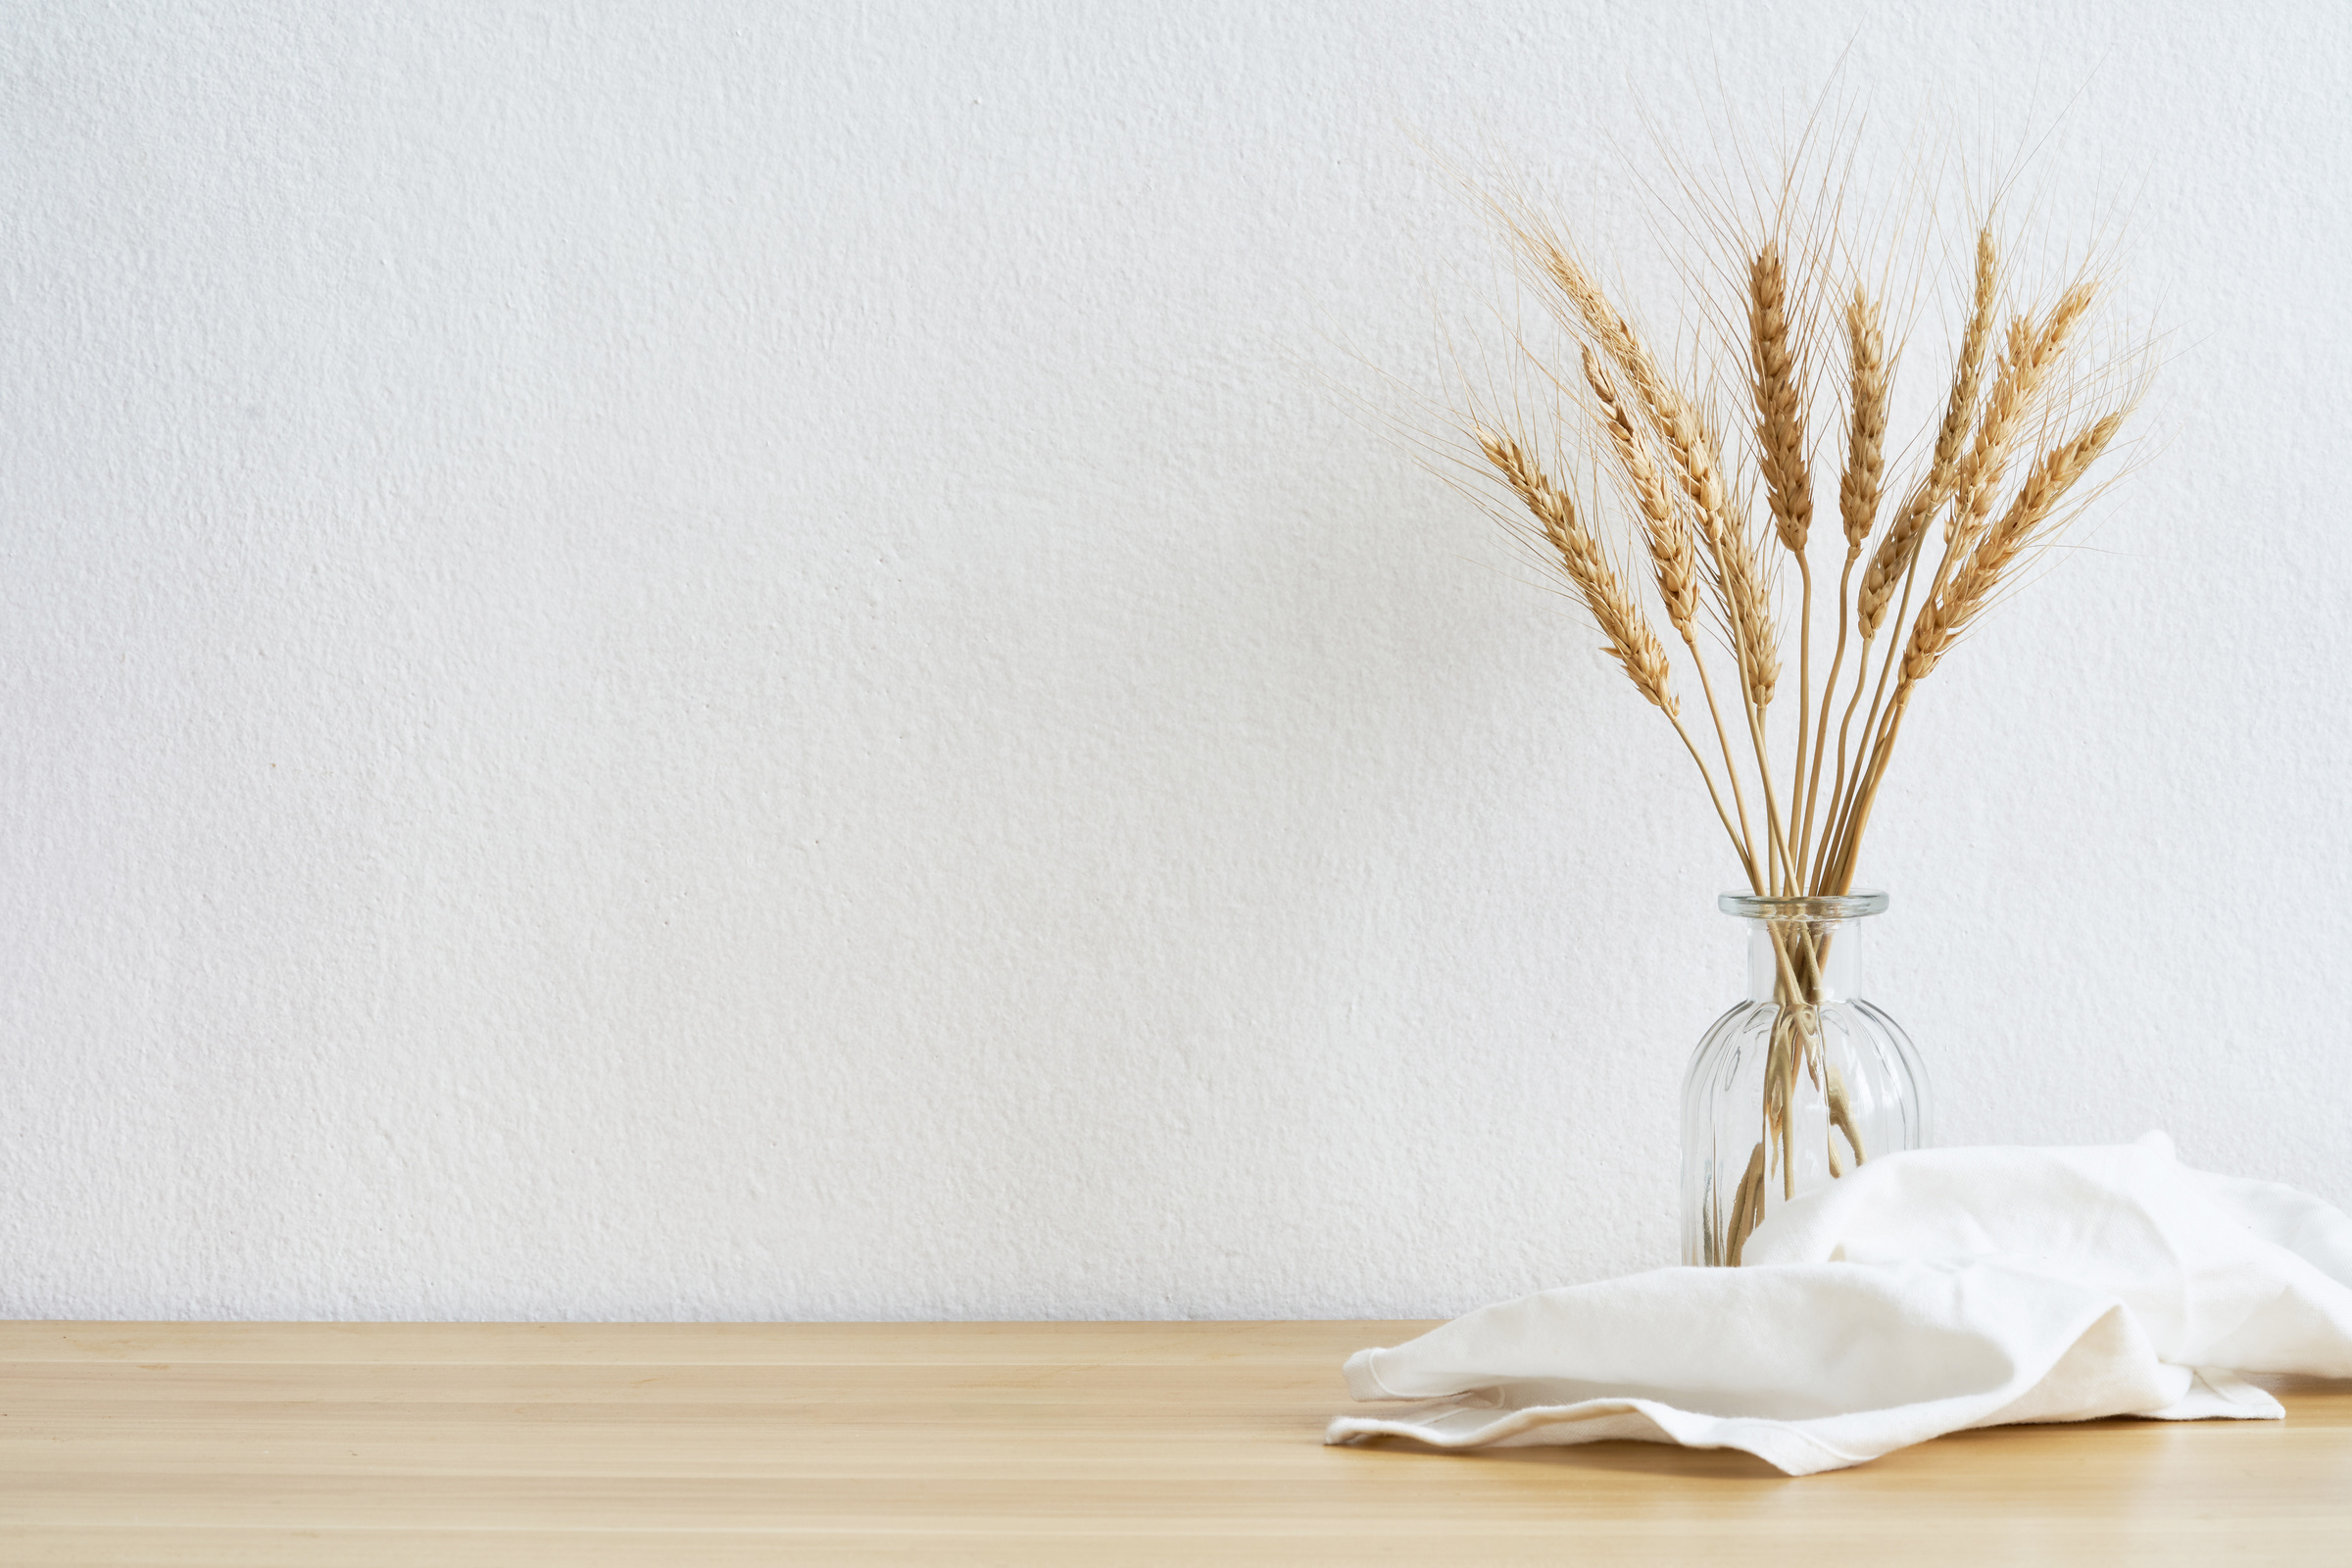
left=1682, top=891, right=1929, bottom=1267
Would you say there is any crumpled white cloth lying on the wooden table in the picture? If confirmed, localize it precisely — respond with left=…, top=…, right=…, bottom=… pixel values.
left=1324, top=1133, right=2352, bottom=1476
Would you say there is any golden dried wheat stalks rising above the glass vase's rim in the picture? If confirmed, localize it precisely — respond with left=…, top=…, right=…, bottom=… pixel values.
left=1460, top=200, right=2135, bottom=896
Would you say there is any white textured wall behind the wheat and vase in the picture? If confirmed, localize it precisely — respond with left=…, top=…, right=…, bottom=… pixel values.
left=0, top=0, right=2352, bottom=1319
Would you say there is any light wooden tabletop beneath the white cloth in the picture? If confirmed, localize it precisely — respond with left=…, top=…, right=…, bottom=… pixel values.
left=0, top=1324, right=2352, bottom=1568
